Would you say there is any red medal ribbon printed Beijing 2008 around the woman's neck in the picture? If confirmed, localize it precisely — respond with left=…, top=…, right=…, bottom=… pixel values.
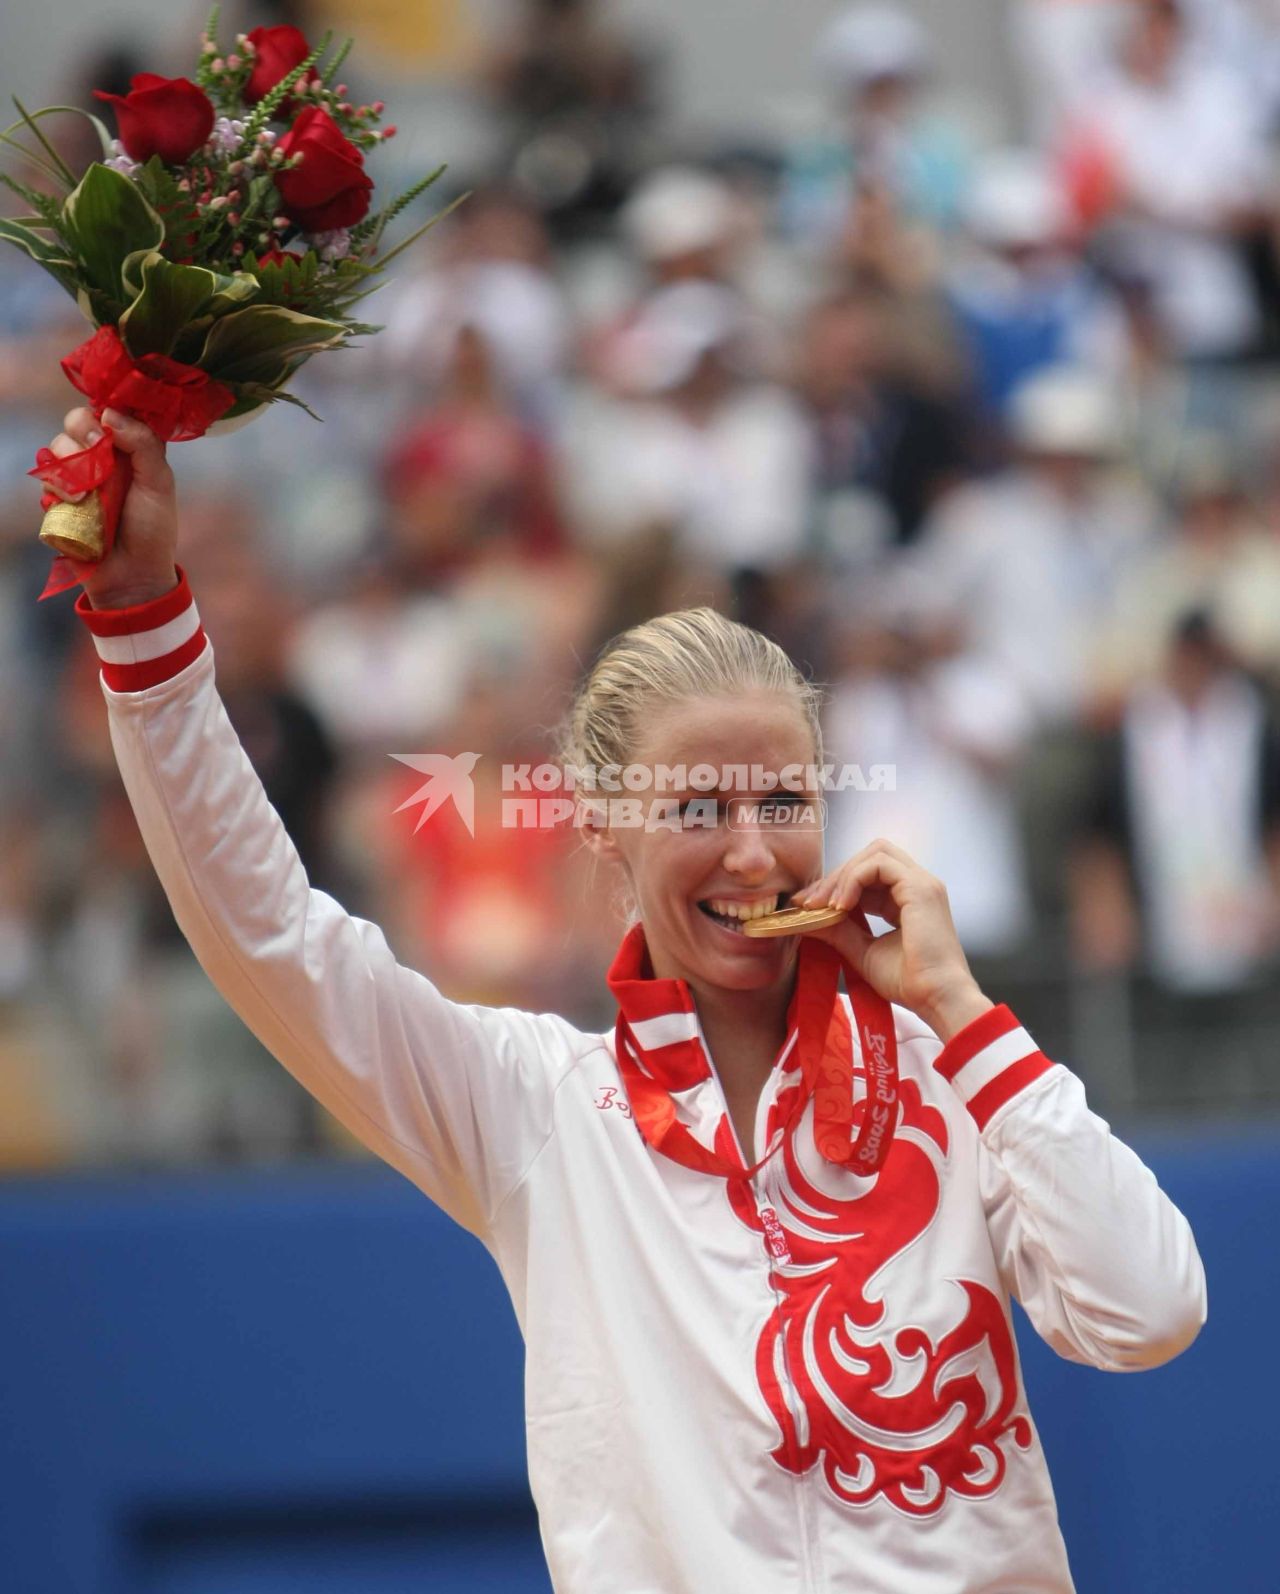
left=609, top=926, right=897, bottom=1178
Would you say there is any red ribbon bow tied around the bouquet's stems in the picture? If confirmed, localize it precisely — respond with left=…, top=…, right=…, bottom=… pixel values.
left=27, top=327, right=236, bottom=598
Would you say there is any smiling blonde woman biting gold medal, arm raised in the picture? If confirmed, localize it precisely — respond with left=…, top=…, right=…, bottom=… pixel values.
left=54, top=410, right=1205, bottom=1594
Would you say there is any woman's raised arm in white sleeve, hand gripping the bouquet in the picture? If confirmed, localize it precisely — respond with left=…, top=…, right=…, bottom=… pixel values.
left=59, top=411, right=580, bottom=1237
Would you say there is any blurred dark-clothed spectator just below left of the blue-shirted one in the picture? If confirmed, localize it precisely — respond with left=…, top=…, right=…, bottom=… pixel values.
left=795, top=287, right=968, bottom=558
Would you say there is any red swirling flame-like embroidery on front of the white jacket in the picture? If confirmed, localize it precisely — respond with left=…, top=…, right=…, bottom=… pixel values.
left=728, top=1079, right=1031, bottom=1516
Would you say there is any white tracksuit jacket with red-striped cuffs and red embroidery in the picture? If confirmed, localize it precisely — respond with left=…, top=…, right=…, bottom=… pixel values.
left=78, top=579, right=1205, bottom=1594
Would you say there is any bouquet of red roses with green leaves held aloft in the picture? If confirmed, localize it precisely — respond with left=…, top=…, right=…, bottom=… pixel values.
left=0, top=8, right=443, bottom=593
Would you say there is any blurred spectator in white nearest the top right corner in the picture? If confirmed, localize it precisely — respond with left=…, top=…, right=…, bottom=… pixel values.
left=1068, top=0, right=1274, bottom=357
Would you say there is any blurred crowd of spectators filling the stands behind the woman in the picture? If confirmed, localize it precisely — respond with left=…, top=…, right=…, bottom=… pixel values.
left=0, top=0, right=1280, bottom=1167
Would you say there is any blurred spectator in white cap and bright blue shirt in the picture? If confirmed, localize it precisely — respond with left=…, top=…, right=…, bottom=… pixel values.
left=947, top=150, right=1127, bottom=418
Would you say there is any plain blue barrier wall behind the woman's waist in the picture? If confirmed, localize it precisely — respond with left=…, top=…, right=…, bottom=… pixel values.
left=0, top=1133, right=1280, bottom=1594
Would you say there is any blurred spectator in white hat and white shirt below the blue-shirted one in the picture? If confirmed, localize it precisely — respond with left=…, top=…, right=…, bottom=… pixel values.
left=904, top=367, right=1154, bottom=725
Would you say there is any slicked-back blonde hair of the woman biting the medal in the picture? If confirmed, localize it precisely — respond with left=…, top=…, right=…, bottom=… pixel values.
left=560, top=607, right=823, bottom=787
